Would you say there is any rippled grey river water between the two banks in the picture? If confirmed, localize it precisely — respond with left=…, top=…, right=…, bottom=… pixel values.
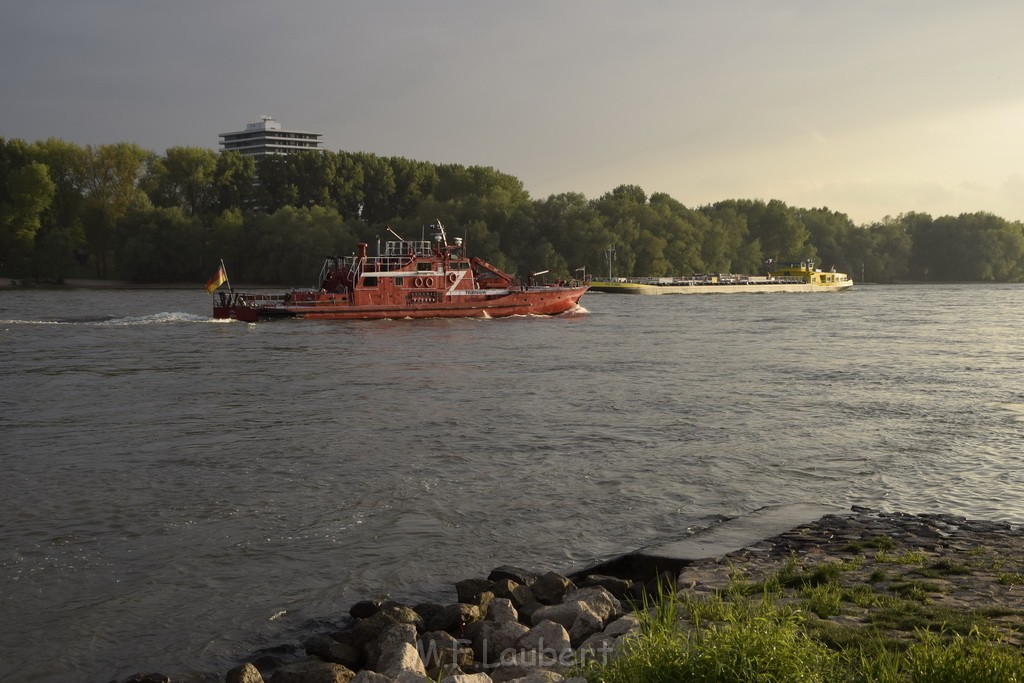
left=0, top=285, right=1024, bottom=681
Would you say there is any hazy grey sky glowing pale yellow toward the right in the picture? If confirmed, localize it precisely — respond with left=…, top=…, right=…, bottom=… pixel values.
left=0, top=0, right=1024, bottom=224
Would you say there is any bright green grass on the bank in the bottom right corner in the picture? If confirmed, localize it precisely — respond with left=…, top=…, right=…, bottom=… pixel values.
left=569, top=581, right=1024, bottom=683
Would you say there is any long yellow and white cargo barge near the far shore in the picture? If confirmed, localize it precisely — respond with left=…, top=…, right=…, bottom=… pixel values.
left=590, top=261, right=853, bottom=294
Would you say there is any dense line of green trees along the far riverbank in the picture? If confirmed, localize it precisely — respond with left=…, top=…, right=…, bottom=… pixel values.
left=0, top=138, right=1024, bottom=285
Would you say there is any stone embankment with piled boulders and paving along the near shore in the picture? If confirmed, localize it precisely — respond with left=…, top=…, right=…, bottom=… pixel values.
left=116, top=508, right=1024, bottom=683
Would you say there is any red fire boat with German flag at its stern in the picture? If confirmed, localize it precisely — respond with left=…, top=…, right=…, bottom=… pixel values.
left=213, top=222, right=588, bottom=323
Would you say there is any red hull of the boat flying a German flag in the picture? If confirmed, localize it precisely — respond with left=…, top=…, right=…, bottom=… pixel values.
left=213, top=287, right=588, bottom=323
